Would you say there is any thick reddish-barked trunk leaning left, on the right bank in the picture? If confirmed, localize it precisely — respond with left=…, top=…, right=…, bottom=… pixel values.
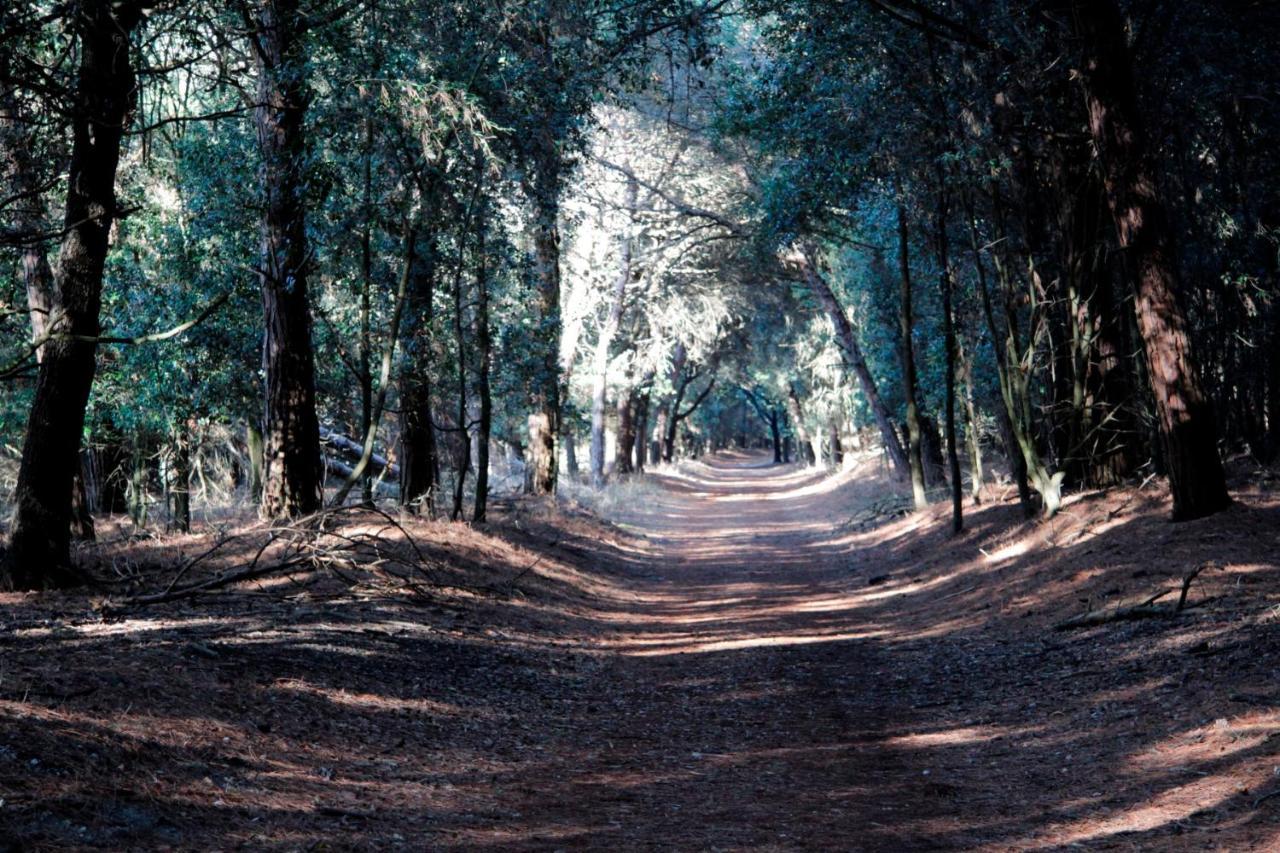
left=1074, top=0, right=1230, bottom=519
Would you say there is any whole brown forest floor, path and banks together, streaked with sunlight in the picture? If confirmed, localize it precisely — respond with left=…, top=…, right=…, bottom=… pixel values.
left=0, top=457, right=1280, bottom=850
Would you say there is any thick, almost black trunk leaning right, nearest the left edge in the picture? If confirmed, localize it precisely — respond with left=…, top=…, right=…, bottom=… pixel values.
left=0, top=0, right=141, bottom=589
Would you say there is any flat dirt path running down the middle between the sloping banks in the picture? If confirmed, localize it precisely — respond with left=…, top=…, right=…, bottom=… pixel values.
left=483, top=456, right=948, bottom=849
